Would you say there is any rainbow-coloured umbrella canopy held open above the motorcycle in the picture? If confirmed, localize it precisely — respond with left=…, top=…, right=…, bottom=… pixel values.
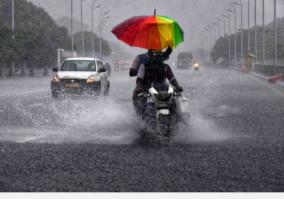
left=112, top=16, right=183, bottom=50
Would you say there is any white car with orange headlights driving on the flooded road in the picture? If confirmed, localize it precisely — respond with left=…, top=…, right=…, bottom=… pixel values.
left=51, top=57, right=110, bottom=98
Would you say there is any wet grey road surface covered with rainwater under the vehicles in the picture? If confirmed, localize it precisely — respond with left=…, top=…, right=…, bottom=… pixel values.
left=0, top=66, right=284, bottom=191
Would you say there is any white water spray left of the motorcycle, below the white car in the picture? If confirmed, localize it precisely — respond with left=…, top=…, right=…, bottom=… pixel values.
left=1, top=98, right=138, bottom=144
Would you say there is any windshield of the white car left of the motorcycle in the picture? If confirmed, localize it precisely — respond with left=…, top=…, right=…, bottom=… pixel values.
left=60, top=60, right=96, bottom=71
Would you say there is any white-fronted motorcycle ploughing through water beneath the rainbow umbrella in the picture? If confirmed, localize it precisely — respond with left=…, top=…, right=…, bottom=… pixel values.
left=140, top=83, right=189, bottom=143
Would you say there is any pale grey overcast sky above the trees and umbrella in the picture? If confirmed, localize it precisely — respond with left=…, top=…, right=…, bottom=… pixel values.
left=30, top=0, right=284, bottom=53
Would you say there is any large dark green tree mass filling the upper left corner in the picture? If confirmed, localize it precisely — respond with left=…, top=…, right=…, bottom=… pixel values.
left=0, top=0, right=71, bottom=67
